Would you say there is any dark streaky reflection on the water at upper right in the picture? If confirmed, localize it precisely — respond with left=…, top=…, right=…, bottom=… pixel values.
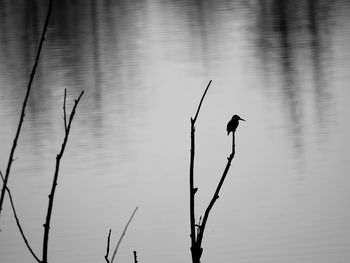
left=256, top=0, right=335, bottom=155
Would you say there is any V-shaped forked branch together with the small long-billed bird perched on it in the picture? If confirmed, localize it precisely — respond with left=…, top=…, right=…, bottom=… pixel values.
left=190, top=81, right=243, bottom=263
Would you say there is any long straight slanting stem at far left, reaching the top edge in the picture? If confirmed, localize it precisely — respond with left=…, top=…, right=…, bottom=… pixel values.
left=0, top=0, right=53, bottom=221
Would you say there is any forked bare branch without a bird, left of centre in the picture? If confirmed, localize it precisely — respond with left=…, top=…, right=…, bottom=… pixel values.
left=42, top=91, right=84, bottom=263
